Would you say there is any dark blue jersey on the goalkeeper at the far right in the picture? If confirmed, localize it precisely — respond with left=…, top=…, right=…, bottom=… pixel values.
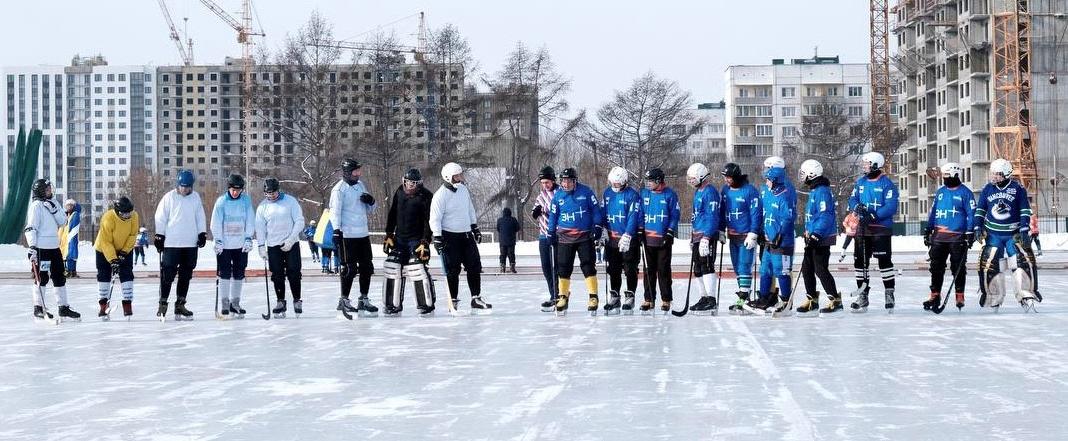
left=973, top=179, right=1031, bottom=235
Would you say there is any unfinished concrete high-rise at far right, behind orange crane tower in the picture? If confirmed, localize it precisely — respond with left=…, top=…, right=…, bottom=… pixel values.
left=891, top=0, right=1068, bottom=220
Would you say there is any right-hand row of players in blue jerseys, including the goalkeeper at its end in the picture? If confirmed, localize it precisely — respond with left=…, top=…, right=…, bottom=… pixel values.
left=531, top=152, right=1041, bottom=315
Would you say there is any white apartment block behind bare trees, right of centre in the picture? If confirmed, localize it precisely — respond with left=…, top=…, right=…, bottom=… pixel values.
left=724, top=57, right=871, bottom=175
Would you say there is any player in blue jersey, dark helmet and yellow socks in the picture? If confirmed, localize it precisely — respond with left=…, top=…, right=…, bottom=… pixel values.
left=548, top=167, right=603, bottom=315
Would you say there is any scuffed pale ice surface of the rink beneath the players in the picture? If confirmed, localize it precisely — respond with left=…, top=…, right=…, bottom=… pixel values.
left=0, top=272, right=1068, bottom=440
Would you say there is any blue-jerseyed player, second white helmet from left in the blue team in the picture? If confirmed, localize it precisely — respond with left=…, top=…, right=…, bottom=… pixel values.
left=686, top=162, right=722, bottom=314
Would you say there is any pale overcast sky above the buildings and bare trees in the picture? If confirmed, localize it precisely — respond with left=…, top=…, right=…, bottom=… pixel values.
left=0, top=0, right=868, bottom=115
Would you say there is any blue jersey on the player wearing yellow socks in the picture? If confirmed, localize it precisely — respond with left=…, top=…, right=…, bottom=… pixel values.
left=548, top=183, right=603, bottom=243
